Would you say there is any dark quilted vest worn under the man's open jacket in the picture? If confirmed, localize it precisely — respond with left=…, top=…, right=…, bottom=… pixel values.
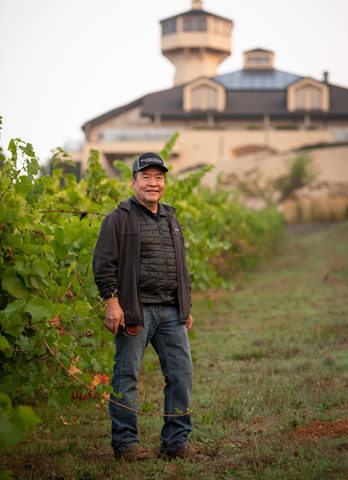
left=132, top=201, right=177, bottom=304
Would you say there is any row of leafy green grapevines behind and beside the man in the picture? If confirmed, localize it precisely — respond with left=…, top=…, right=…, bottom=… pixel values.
left=0, top=124, right=282, bottom=450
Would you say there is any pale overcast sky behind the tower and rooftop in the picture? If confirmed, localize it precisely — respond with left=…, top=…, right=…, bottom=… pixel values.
left=0, top=0, right=348, bottom=161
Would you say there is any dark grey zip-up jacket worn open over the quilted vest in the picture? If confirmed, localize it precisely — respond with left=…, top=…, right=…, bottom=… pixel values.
left=93, top=198, right=191, bottom=325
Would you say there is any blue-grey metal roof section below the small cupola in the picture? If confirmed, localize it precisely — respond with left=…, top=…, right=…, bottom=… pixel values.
left=213, top=69, right=303, bottom=90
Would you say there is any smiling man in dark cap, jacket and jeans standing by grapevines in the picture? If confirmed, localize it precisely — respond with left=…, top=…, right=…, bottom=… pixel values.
left=93, top=152, right=203, bottom=461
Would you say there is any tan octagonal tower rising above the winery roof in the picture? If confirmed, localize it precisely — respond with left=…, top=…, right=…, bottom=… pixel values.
left=160, top=0, right=233, bottom=85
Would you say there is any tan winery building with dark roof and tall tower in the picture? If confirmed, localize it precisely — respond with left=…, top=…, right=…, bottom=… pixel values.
left=73, top=0, right=348, bottom=176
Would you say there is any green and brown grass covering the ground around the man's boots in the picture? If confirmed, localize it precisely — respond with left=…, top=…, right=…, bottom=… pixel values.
left=0, top=223, right=348, bottom=480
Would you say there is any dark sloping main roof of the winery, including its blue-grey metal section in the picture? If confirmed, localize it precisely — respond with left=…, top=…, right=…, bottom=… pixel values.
left=82, top=70, right=348, bottom=131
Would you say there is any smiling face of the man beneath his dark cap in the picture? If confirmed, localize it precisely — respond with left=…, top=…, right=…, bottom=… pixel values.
left=132, top=167, right=165, bottom=212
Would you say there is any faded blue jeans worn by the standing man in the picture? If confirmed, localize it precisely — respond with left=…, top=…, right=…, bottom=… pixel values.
left=109, top=305, right=192, bottom=453
